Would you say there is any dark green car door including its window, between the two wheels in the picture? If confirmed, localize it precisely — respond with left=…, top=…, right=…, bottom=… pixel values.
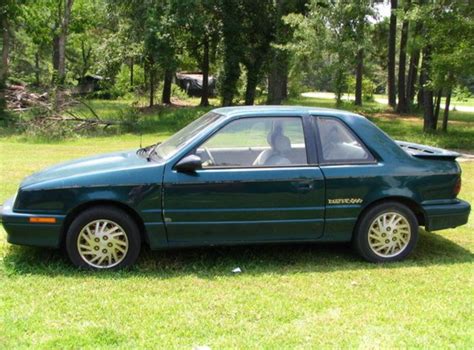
left=163, top=116, right=325, bottom=245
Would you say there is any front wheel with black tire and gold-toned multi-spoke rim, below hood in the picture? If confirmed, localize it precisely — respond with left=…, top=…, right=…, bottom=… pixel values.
left=66, top=206, right=141, bottom=270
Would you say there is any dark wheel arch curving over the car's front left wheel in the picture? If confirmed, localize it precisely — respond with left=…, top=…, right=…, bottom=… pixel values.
left=60, top=200, right=149, bottom=247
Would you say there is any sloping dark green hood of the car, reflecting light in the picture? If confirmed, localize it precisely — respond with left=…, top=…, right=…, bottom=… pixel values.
left=20, top=150, right=161, bottom=189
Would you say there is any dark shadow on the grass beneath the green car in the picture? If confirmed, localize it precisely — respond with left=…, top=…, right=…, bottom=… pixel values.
left=0, top=229, right=474, bottom=279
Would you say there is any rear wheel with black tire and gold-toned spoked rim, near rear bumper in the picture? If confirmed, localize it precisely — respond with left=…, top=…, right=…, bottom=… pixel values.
left=353, top=202, right=418, bottom=263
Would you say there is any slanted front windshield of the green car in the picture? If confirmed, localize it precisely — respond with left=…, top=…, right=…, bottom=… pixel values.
left=155, top=112, right=221, bottom=159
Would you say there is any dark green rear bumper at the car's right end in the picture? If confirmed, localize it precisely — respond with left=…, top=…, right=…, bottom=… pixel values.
left=423, top=200, right=471, bottom=231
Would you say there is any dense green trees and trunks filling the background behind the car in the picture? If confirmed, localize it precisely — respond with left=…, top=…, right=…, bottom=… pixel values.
left=0, top=0, right=474, bottom=131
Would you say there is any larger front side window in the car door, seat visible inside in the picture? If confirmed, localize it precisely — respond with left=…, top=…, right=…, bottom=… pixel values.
left=196, top=117, right=308, bottom=168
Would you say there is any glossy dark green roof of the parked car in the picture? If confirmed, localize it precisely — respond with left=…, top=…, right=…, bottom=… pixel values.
left=212, top=105, right=363, bottom=118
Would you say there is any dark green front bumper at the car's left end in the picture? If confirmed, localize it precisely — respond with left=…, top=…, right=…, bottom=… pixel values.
left=0, top=198, right=65, bottom=248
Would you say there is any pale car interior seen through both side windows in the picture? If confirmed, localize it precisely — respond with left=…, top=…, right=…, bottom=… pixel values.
left=195, top=118, right=371, bottom=168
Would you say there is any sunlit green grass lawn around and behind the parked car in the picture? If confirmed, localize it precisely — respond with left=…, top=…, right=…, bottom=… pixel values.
left=0, top=101, right=474, bottom=349
